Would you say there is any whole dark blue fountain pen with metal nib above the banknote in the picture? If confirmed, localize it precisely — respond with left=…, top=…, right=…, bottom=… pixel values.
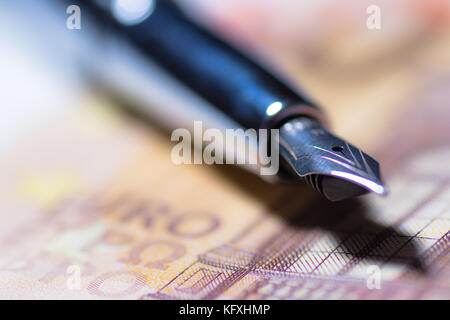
left=77, top=0, right=386, bottom=201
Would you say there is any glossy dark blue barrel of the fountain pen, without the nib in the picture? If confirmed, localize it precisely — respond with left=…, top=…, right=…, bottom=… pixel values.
left=84, top=0, right=322, bottom=129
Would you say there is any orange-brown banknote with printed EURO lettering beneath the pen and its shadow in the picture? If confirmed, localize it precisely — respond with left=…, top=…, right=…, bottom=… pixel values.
left=0, top=84, right=450, bottom=299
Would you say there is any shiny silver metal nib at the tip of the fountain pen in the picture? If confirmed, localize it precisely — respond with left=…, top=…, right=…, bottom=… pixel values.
left=280, top=117, right=387, bottom=201
